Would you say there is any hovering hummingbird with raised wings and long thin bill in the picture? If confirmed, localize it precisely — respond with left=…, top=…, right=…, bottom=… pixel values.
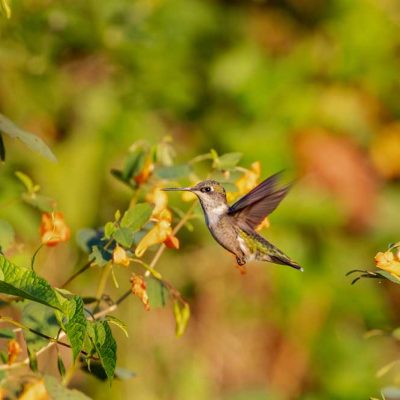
left=163, top=172, right=303, bottom=271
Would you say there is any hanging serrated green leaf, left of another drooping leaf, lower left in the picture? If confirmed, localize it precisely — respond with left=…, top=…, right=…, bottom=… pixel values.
left=64, top=296, right=87, bottom=361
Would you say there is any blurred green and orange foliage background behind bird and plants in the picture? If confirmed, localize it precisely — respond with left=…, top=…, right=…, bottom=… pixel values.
left=0, top=0, right=400, bottom=400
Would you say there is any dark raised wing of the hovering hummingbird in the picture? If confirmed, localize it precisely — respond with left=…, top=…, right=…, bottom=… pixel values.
left=228, top=172, right=290, bottom=230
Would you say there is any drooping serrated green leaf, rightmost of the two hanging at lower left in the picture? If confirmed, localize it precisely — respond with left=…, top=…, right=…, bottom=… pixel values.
left=87, top=321, right=117, bottom=383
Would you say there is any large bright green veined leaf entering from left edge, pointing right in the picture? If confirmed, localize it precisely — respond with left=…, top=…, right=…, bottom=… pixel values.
left=0, top=255, right=63, bottom=311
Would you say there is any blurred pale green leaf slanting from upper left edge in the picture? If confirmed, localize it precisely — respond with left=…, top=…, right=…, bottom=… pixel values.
left=0, top=112, right=57, bottom=162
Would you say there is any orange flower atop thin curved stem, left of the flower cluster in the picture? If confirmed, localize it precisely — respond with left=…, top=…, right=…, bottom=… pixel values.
left=40, top=212, right=71, bottom=246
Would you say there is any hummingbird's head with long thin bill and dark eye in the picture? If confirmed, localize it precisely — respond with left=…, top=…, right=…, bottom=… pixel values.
left=163, top=180, right=226, bottom=211
